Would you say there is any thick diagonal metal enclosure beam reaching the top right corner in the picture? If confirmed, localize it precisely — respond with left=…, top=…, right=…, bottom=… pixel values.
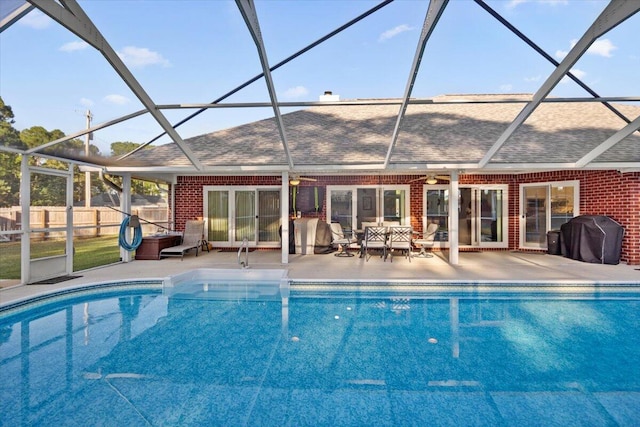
left=478, top=0, right=640, bottom=168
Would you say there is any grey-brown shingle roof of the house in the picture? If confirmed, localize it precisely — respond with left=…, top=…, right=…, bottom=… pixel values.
left=134, top=95, right=640, bottom=171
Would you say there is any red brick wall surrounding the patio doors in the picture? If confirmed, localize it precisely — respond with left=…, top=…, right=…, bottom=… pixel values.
left=175, top=170, right=640, bottom=265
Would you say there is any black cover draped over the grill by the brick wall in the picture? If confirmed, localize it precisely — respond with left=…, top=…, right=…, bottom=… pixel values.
left=560, top=215, right=624, bottom=264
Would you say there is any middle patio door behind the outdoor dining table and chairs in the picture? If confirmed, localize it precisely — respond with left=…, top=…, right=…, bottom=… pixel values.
left=327, top=185, right=410, bottom=229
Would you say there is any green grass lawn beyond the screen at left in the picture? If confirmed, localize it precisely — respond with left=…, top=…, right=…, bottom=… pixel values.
left=0, top=235, right=120, bottom=279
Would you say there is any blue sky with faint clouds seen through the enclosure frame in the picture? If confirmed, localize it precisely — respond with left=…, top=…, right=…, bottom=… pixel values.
left=0, top=0, right=640, bottom=155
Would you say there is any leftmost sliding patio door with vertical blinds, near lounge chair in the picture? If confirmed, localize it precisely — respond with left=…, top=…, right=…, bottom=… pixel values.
left=204, top=187, right=280, bottom=247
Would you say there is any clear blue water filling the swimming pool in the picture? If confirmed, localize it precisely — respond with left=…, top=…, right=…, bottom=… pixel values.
left=0, top=283, right=640, bottom=426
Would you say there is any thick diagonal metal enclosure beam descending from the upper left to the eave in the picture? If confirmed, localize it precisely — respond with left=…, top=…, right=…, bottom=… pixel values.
left=28, top=0, right=202, bottom=170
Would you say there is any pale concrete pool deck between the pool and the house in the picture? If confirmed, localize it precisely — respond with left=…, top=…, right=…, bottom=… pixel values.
left=0, top=251, right=640, bottom=306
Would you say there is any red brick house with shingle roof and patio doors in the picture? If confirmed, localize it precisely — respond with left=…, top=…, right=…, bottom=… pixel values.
left=126, top=94, right=640, bottom=264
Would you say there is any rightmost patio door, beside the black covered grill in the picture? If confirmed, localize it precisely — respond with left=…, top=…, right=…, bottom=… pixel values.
left=520, top=181, right=580, bottom=249
